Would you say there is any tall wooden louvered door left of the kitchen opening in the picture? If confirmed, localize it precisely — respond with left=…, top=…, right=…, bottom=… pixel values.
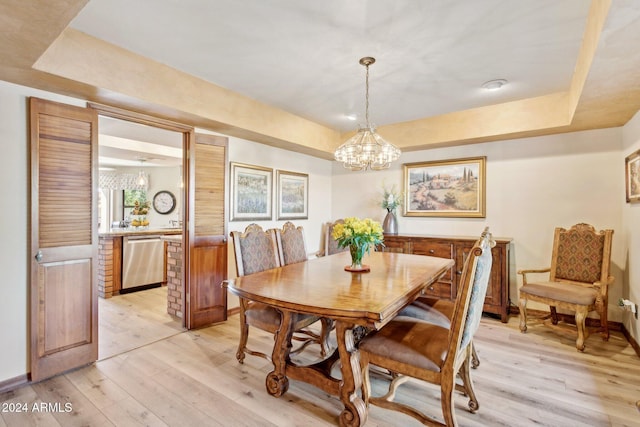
left=29, top=98, right=98, bottom=381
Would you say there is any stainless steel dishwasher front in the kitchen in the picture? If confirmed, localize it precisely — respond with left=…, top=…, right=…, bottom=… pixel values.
left=122, top=235, right=164, bottom=289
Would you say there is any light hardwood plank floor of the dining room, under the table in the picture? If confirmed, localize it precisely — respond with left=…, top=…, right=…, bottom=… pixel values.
left=0, top=302, right=640, bottom=427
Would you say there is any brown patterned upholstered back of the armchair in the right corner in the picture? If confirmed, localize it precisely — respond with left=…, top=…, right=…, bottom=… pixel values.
left=549, top=223, right=613, bottom=283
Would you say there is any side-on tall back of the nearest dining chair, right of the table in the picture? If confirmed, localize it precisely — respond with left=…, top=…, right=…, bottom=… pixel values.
left=445, top=227, right=495, bottom=363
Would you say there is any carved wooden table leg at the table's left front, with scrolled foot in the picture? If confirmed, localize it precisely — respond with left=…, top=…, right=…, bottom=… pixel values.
left=265, top=311, right=295, bottom=397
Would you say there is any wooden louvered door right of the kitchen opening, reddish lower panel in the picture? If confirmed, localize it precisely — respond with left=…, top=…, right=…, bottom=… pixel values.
left=185, top=134, right=227, bottom=329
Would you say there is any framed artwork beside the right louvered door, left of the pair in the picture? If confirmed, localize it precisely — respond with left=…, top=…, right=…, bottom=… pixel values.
left=230, top=163, right=273, bottom=221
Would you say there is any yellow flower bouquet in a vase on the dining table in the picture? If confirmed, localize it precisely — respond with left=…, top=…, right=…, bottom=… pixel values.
left=331, top=217, right=384, bottom=270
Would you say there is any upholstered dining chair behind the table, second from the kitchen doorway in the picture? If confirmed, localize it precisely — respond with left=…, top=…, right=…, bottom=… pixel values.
left=275, top=221, right=334, bottom=357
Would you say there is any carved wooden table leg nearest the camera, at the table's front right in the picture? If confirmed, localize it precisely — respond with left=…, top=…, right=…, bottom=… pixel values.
left=336, top=321, right=367, bottom=427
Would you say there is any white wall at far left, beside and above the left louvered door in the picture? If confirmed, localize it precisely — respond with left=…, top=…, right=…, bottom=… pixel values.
left=0, top=81, right=83, bottom=382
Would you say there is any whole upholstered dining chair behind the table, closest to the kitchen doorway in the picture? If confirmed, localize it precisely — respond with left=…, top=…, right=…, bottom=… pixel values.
left=231, top=224, right=324, bottom=363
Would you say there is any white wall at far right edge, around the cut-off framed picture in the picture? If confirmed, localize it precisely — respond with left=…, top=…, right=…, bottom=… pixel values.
left=619, top=112, right=640, bottom=342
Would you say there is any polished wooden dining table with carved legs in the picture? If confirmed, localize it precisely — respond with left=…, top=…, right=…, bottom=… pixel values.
left=227, top=251, right=454, bottom=426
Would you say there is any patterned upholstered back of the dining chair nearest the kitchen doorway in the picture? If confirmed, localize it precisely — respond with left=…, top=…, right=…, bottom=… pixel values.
left=231, top=224, right=280, bottom=276
